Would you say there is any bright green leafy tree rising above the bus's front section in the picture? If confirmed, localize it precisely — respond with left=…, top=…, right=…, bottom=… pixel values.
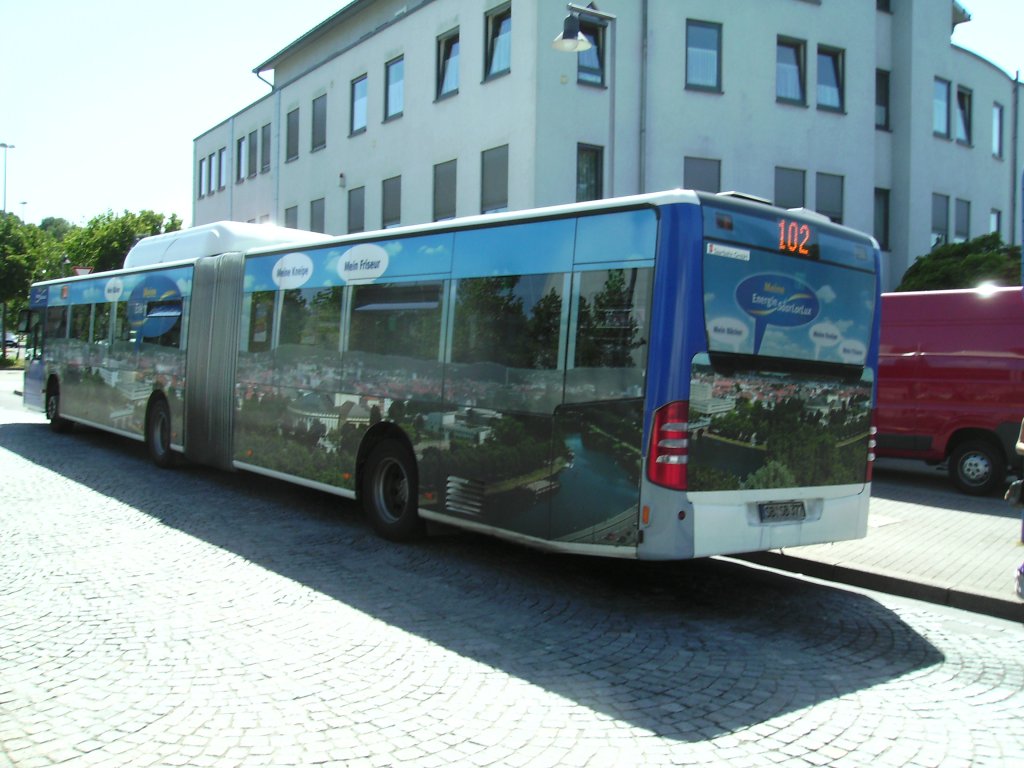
left=63, top=211, right=181, bottom=272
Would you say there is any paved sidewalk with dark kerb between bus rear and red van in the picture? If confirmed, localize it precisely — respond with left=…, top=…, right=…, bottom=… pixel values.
left=742, top=460, right=1024, bottom=622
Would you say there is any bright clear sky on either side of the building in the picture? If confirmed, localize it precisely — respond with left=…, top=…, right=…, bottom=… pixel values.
left=0, top=0, right=1024, bottom=225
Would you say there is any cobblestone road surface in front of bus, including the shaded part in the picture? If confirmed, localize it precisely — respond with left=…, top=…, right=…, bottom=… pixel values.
left=0, top=387, right=1024, bottom=768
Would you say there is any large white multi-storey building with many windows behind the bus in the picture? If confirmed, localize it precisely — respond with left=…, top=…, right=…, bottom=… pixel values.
left=193, top=0, right=1022, bottom=289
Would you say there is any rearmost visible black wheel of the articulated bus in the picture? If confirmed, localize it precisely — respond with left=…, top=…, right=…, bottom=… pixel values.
left=361, top=440, right=425, bottom=542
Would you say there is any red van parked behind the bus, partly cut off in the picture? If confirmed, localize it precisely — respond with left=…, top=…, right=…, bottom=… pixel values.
left=876, top=287, right=1024, bottom=496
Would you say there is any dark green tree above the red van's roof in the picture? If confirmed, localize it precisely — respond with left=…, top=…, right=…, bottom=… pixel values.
left=896, top=232, right=1021, bottom=291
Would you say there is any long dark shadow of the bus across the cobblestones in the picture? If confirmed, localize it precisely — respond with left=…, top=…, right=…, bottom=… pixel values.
left=0, top=424, right=943, bottom=742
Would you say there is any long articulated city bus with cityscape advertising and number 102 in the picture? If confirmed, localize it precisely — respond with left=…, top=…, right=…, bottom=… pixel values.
left=24, top=190, right=880, bottom=559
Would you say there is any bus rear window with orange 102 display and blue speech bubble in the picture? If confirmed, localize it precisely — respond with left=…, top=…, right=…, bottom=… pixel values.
left=703, top=207, right=877, bottom=366
